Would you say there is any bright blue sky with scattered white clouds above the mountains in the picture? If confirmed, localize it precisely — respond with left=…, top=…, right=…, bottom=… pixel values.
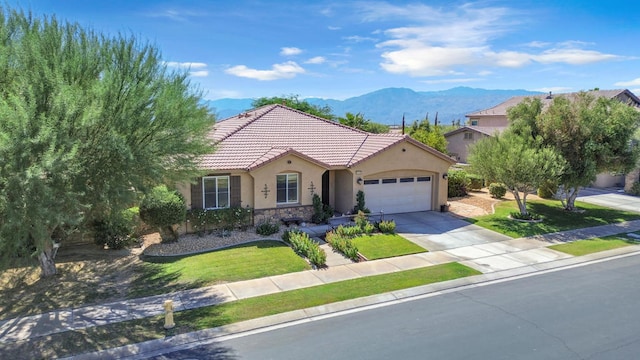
left=9, top=0, right=640, bottom=99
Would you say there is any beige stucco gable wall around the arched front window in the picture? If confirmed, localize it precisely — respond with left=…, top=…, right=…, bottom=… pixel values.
left=250, top=155, right=325, bottom=209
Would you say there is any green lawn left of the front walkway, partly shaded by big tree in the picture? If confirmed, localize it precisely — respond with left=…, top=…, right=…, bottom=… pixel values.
left=130, top=241, right=310, bottom=297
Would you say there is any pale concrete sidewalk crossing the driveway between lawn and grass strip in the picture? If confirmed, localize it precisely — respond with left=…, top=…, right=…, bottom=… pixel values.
left=0, top=215, right=640, bottom=344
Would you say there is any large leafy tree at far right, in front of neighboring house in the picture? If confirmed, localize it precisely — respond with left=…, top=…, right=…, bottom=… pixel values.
left=507, top=92, right=640, bottom=210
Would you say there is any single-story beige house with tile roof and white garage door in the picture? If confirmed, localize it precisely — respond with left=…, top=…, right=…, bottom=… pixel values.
left=182, top=105, right=454, bottom=222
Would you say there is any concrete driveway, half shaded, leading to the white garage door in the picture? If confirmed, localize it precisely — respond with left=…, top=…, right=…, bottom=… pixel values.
left=385, top=211, right=511, bottom=251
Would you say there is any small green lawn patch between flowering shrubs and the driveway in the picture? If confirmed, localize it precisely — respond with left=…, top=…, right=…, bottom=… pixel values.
left=351, top=234, right=427, bottom=260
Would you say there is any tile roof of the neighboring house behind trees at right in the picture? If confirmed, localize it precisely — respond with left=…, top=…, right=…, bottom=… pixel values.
left=466, top=89, right=640, bottom=117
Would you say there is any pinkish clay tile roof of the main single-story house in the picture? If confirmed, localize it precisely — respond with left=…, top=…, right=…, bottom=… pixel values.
left=200, top=105, right=446, bottom=170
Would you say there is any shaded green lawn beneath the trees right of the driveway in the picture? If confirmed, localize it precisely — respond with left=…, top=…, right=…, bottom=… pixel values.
left=469, top=200, right=640, bottom=238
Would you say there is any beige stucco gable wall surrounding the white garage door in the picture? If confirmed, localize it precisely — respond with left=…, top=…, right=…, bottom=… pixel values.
left=351, top=141, right=451, bottom=209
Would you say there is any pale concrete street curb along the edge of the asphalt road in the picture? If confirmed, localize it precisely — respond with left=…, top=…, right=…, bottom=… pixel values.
left=63, top=245, right=640, bottom=360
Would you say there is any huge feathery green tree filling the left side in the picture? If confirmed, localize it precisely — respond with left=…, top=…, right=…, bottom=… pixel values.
left=0, top=8, right=214, bottom=276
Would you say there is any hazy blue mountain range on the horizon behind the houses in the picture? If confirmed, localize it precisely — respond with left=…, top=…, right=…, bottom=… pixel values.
left=208, top=86, right=541, bottom=125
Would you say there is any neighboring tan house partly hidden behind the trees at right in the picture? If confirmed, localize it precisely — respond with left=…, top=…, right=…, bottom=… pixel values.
left=444, top=89, right=640, bottom=187
